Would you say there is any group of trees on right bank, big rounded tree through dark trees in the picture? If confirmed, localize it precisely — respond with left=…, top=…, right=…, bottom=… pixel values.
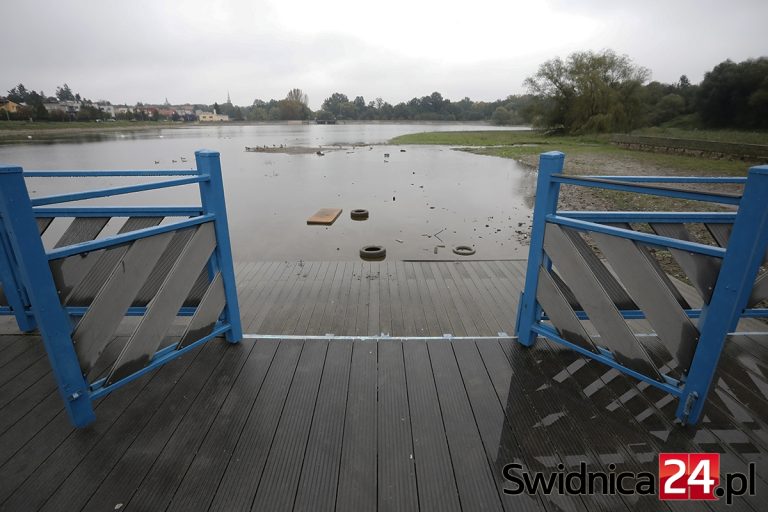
left=525, top=50, right=768, bottom=134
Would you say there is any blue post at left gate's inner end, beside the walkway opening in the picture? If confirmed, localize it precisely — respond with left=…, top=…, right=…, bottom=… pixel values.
left=195, top=150, right=243, bottom=343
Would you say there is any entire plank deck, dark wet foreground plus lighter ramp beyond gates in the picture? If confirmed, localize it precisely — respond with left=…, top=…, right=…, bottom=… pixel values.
left=0, top=262, right=768, bottom=512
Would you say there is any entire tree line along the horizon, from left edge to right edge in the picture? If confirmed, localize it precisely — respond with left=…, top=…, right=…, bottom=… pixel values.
left=6, top=50, right=768, bottom=130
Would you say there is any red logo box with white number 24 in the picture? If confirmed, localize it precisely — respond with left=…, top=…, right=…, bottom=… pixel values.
left=659, top=453, right=720, bottom=500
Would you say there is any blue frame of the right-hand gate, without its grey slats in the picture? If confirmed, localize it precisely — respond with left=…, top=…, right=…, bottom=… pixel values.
left=516, top=152, right=768, bottom=424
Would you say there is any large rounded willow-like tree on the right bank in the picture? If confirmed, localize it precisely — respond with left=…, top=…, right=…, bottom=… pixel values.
left=525, top=50, right=650, bottom=134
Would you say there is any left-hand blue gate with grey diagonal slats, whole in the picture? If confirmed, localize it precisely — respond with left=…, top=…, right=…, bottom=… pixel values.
left=0, top=151, right=242, bottom=427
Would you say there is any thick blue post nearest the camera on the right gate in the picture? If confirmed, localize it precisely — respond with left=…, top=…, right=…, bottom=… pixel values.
left=676, top=165, right=768, bottom=424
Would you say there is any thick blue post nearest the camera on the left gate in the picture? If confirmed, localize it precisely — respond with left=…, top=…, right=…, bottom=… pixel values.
left=0, top=166, right=96, bottom=427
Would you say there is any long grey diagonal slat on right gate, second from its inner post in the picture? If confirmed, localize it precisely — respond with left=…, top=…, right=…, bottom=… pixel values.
left=544, top=223, right=663, bottom=381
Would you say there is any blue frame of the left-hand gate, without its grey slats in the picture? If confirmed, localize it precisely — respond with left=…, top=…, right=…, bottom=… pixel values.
left=0, top=151, right=242, bottom=427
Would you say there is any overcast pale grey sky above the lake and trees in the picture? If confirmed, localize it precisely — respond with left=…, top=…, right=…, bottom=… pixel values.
left=0, top=0, right=768, bottom=109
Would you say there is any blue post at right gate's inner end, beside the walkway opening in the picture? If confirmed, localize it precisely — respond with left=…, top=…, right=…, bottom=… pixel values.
left=515, top=151, right=565, bottom=347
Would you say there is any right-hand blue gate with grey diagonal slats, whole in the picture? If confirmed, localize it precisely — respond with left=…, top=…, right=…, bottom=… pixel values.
left=516, top=152, right=768, bottom=424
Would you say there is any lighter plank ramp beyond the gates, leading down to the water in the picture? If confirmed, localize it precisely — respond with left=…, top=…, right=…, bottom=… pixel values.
left=231, top=261, right=525, bottom=336
